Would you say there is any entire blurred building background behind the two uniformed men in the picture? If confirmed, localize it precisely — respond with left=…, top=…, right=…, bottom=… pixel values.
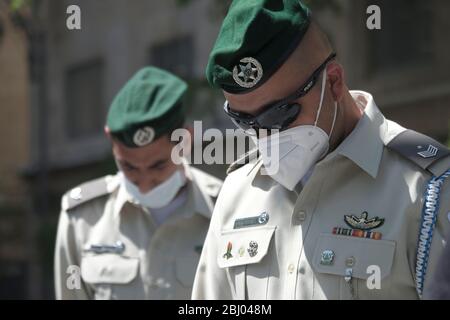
left=0, top=0, right=450, bottom=299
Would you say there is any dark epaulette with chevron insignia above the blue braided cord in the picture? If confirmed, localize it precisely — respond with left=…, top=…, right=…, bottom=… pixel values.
left=387, top=130, right=450, bottom=176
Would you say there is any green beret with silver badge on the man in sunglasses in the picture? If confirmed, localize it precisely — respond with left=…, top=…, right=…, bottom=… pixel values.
left=206, top=0, right=311, bottom=94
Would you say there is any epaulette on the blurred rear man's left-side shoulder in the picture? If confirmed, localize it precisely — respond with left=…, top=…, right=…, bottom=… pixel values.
left=62, top=176, right=118, bottom=211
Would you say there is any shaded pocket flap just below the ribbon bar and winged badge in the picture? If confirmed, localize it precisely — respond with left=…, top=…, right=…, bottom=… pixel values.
left=313, top=234, right=395, bottom=279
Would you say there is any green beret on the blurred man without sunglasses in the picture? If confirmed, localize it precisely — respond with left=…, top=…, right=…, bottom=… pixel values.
left=106, top=67, right=187, bottom=148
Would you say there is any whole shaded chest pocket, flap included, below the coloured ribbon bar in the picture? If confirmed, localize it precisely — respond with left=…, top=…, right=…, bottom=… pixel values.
left=312, top=234, right=396, bottom=299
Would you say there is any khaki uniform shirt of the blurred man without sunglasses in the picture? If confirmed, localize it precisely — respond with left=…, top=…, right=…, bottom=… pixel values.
left=55, top=165, right=222, bottom=299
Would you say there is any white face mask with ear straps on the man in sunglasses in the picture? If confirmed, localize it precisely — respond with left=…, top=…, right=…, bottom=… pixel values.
left=258, top=71, right=337, bottom=191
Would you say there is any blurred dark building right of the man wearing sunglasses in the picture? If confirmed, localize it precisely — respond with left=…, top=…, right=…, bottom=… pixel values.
left=330, top=0, right=450, bottom=142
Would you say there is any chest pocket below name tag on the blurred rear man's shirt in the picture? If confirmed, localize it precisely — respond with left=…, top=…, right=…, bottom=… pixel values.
left=81, top=254, right=139, bottom=299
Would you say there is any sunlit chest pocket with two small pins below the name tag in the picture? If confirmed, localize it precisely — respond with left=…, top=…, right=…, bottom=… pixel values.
left=217, top=227, right=276, bottom=300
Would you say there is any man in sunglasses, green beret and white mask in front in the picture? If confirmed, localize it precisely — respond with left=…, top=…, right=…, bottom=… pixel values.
left=193, top=0, right=450, bottom=299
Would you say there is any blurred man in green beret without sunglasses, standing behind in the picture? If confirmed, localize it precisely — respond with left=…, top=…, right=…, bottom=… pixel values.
left=55, top=67, right=222, bottom=299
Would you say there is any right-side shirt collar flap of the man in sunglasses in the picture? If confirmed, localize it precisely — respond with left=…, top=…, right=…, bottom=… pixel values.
left=330, top=91, right=387, bottom=178
